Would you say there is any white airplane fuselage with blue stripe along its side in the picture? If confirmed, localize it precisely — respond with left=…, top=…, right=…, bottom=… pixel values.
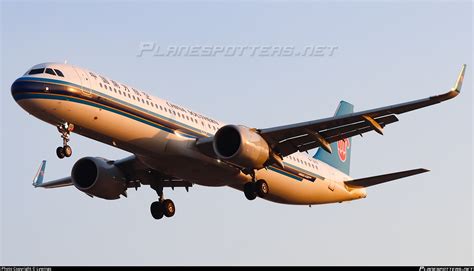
left=12, top=63, right=366, bottom=205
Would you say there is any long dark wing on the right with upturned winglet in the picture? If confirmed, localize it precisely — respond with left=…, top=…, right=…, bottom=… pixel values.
left=258, top=65, right=466, bottom=156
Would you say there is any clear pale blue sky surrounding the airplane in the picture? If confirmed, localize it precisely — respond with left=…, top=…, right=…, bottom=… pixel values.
left=0, top=1, right=474, bottom=265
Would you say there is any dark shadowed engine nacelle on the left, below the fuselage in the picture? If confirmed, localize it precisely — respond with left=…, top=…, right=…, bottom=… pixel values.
left=71, top=157, right=127, bottom=199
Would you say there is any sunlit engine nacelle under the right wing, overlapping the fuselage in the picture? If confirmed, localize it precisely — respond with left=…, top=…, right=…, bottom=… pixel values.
left=213, top=125, right=270, bottom=169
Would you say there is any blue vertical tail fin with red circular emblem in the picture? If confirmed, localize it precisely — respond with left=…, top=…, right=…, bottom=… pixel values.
left=313, top=101, right=354, bottom=175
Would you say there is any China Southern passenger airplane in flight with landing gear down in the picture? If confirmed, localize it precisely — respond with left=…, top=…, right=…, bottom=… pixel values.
left=11, top=63, right=466, bottom=219
